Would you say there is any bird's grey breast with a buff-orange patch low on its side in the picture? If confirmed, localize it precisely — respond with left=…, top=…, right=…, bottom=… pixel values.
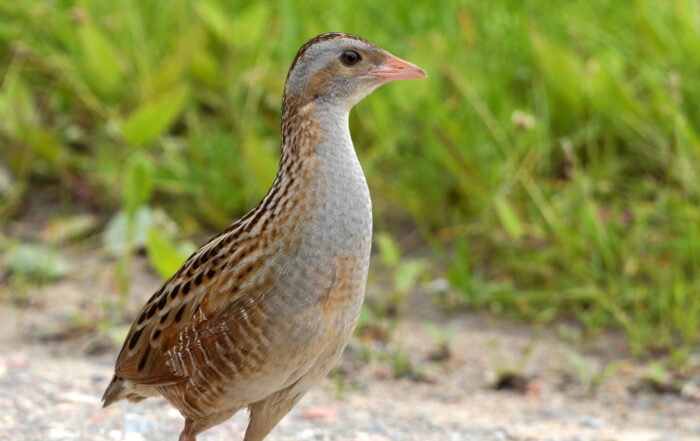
left=262, top=139, right=372, bottom=328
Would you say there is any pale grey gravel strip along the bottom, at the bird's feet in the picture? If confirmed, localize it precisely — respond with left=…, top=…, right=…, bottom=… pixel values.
left=0, top=324, right=700, bottom=441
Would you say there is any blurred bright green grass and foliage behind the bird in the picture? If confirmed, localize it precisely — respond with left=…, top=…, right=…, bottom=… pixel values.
left=0, top=0, right=700, bottom=360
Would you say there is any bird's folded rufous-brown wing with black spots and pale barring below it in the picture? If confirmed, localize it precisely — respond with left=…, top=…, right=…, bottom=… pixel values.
left=116, top=223, right=271, bottom=385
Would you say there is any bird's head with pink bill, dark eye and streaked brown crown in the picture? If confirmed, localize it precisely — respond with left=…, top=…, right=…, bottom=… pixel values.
left=285, top=33, right=427, bottom=111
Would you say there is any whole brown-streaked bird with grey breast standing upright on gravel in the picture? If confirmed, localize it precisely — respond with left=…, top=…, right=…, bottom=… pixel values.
left=102, top=32, right=427, bottom=441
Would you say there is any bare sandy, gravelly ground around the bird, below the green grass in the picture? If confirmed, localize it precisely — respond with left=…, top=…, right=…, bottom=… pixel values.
left=0, top=249, right=700, bottom=441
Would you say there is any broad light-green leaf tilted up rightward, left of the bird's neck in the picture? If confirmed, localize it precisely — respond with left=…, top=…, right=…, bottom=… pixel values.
left=122, top=86, right=189, bottom=146
